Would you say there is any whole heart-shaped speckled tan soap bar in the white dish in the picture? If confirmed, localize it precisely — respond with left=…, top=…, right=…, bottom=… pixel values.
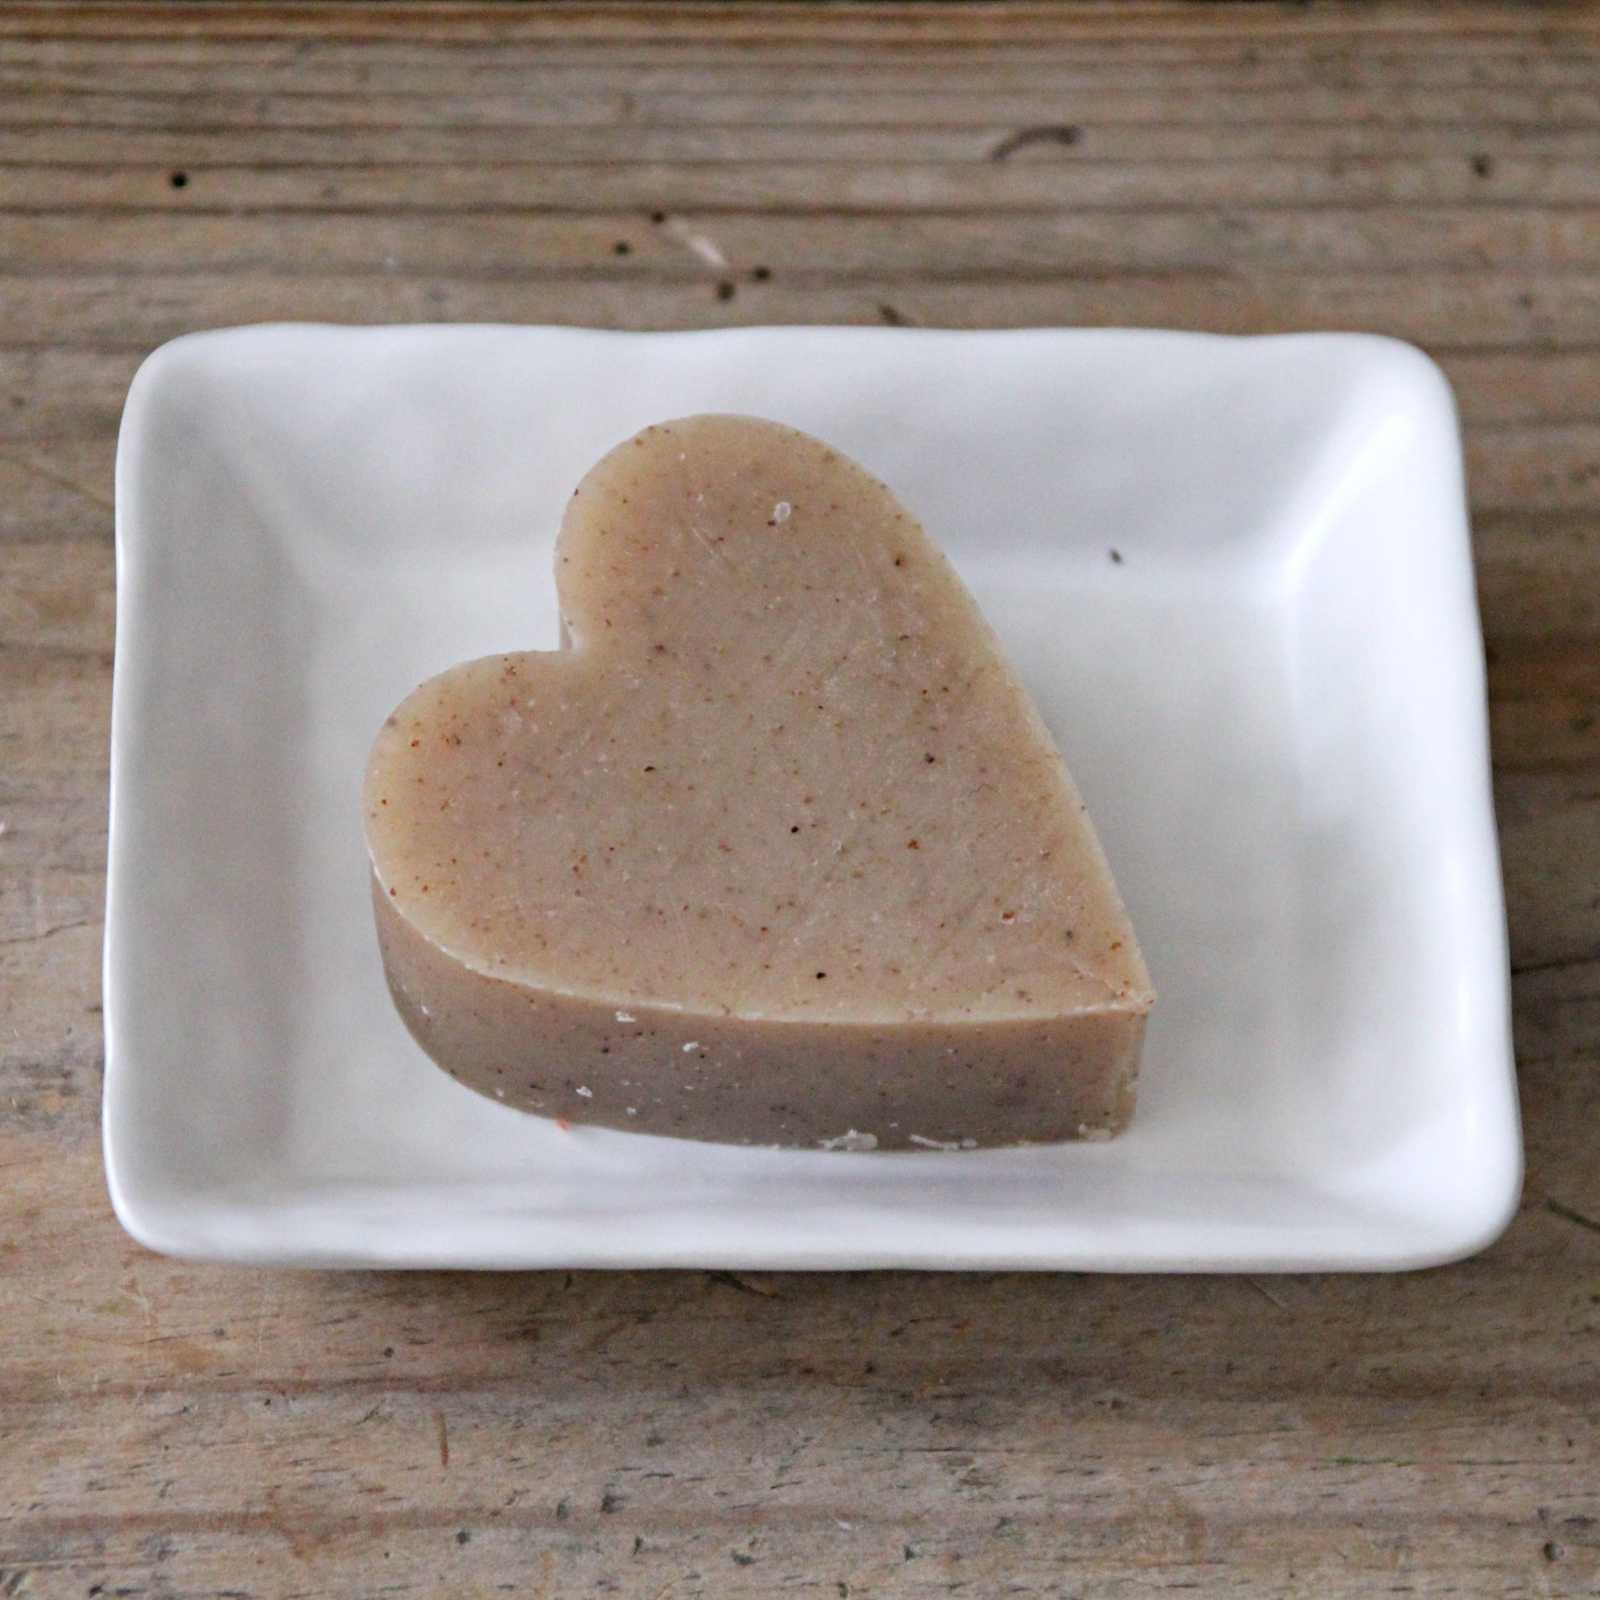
left=363, top=416, right=1154, bottom=1149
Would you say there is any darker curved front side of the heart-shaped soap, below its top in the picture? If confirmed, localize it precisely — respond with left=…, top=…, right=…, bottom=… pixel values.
left=374, top=893, right=1144, bottom=1150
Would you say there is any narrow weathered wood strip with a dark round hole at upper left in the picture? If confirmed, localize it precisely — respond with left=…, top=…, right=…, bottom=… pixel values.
left=9, top=152, right=1600, bottom=219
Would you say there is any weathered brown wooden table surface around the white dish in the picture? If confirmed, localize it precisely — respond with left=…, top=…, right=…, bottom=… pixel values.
left=0, top=5, right=1600, bottom=1600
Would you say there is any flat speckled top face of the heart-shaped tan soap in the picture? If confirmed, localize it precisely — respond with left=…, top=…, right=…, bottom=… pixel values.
left=363, top=416, right=1152, bottom=1024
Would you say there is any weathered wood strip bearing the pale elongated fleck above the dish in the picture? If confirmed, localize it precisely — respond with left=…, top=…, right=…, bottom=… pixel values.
left=0, top=206, right=1600, bottom=283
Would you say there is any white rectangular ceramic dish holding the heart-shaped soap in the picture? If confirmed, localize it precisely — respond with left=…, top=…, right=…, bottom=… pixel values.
left=104, top=326, right=1520, bottom=1270
